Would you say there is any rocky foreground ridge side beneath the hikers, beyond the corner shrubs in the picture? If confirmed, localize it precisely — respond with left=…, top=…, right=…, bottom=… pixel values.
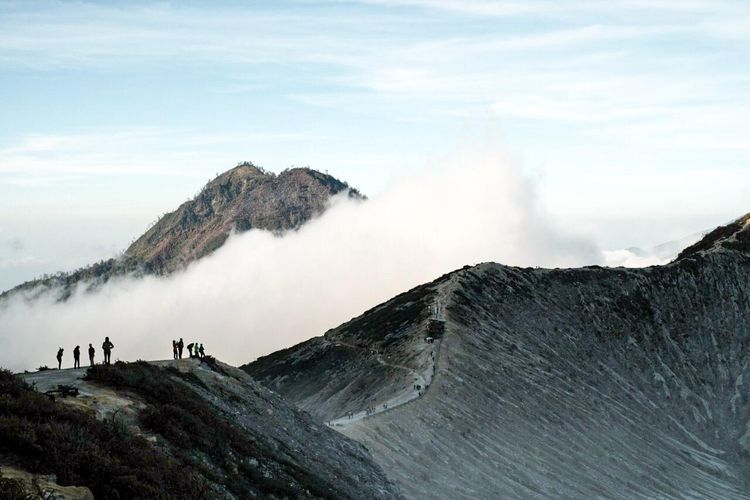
left=10, top=359, right=400, bottom=499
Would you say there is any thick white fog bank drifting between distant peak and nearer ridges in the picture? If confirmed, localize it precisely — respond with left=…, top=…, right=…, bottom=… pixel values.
left=0, top=151, right=636, bottom=370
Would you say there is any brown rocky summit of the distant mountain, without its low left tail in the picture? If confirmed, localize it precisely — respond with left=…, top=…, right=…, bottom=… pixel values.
left=125, top=163, right=359, bottom=273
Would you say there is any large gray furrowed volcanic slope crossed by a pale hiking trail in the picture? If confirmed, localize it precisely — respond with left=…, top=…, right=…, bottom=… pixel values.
left=245, top=216, right=750, bottom=499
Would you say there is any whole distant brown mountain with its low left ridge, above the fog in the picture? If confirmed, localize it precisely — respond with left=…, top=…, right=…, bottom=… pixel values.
left=0, top=162, right=364, bottom=300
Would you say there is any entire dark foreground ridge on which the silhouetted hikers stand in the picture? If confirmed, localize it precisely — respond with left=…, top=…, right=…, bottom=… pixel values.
left=10, top=359, right=400, bottom=499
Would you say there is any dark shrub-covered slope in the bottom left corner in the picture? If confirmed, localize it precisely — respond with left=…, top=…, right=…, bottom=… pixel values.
left=0, top=370, right=203, bottom=498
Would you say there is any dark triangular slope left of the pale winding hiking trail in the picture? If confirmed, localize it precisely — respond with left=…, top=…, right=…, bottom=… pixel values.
left=242, top=276, right=450, bottom=421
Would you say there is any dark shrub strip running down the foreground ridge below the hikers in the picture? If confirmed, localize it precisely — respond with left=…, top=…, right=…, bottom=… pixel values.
left=86, top=359, right=346, bottom=498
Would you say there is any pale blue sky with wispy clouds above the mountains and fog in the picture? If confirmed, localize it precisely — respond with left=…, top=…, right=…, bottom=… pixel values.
left=0, top=0, right=750, bottom=288
